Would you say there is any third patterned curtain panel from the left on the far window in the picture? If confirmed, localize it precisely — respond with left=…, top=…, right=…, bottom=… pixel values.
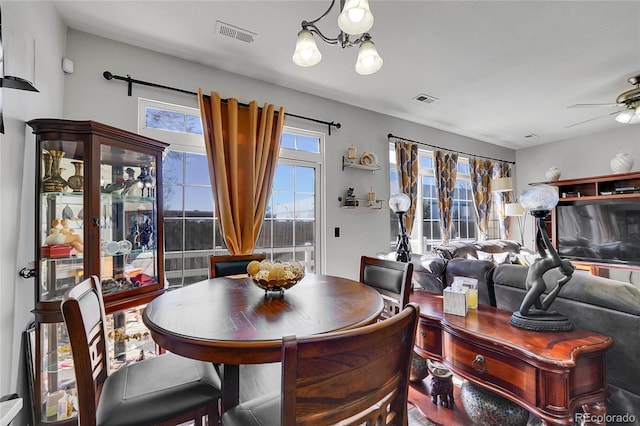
left=469, top=157, right=493, bottom=241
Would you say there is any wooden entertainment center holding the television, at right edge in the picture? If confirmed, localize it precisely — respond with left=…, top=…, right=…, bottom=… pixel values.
left=545, top=172, right=640, bottom=275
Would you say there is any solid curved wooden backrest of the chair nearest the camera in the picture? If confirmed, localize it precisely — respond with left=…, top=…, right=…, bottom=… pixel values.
left=281, top=303, right=419, bottom=426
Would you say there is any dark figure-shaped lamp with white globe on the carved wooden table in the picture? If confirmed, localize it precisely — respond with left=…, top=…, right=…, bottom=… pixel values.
left=509, top=185, right=574, bottom=331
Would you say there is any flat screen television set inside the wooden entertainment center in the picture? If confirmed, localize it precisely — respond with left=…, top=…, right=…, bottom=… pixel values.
left=556, top=199, right=640, bottom=266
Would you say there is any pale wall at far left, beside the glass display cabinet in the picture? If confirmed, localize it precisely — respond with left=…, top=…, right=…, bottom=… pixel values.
left=0, top=1, right=66, bottom=424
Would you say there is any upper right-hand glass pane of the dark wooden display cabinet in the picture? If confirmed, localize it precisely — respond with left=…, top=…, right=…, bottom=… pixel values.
left=100, top=145, right=159, bottom=296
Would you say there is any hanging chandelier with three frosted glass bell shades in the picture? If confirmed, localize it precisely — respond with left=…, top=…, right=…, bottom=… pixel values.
left=292, top=0, right=383, bottom=75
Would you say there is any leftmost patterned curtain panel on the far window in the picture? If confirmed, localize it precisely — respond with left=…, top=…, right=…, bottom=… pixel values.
left=395, top=141, right=419, bottom=231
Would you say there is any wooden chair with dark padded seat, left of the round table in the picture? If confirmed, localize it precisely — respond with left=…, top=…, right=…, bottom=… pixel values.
left=62, top=276, right=221, bottom=426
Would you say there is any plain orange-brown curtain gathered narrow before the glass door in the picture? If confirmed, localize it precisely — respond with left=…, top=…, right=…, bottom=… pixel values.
left=198, top=89, right=284, bottom=254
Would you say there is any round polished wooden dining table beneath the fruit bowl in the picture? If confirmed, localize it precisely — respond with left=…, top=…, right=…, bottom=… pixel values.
left=143, top=274, right=384, bottom=410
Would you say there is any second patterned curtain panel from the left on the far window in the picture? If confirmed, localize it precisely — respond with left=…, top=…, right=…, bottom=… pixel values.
left=433, top=150, right=458, bottom=244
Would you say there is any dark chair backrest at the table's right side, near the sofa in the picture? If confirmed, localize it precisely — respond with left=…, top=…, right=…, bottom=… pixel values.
left=360, top=256, right=413, bottom=318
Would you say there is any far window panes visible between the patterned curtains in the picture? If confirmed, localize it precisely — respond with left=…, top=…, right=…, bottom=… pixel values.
left=389, top=144, right=499, bottom=253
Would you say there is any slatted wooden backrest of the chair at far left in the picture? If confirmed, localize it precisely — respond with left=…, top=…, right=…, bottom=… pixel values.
left=62, top=276, right=109, bottom=425
